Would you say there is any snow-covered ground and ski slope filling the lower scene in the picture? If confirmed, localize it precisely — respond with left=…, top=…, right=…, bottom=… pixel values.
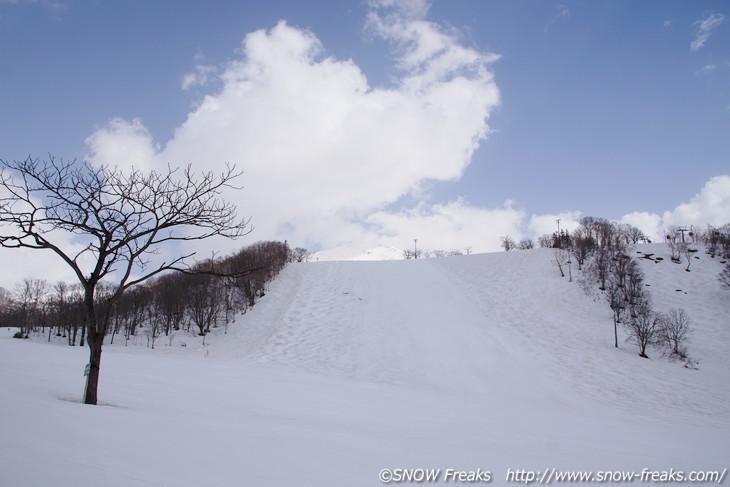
left=0, top=245, right=730, bottom=487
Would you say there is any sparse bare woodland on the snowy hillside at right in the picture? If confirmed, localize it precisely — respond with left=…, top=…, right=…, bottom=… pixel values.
left=502, top=217, right=730, bottom=367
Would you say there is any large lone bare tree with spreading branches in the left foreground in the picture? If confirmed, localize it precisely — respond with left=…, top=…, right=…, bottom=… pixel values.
left=0, top=157, right=250, bottom=404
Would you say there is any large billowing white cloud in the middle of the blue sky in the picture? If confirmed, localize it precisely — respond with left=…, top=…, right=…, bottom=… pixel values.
left=82, top=1, right=499, bottom=255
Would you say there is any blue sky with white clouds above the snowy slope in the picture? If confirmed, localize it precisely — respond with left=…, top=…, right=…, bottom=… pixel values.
left=0, top=0, right=730, bottom=282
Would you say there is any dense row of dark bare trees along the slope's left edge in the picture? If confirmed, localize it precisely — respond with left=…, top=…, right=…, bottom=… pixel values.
left=0, top=241, right=296, bottom=348
